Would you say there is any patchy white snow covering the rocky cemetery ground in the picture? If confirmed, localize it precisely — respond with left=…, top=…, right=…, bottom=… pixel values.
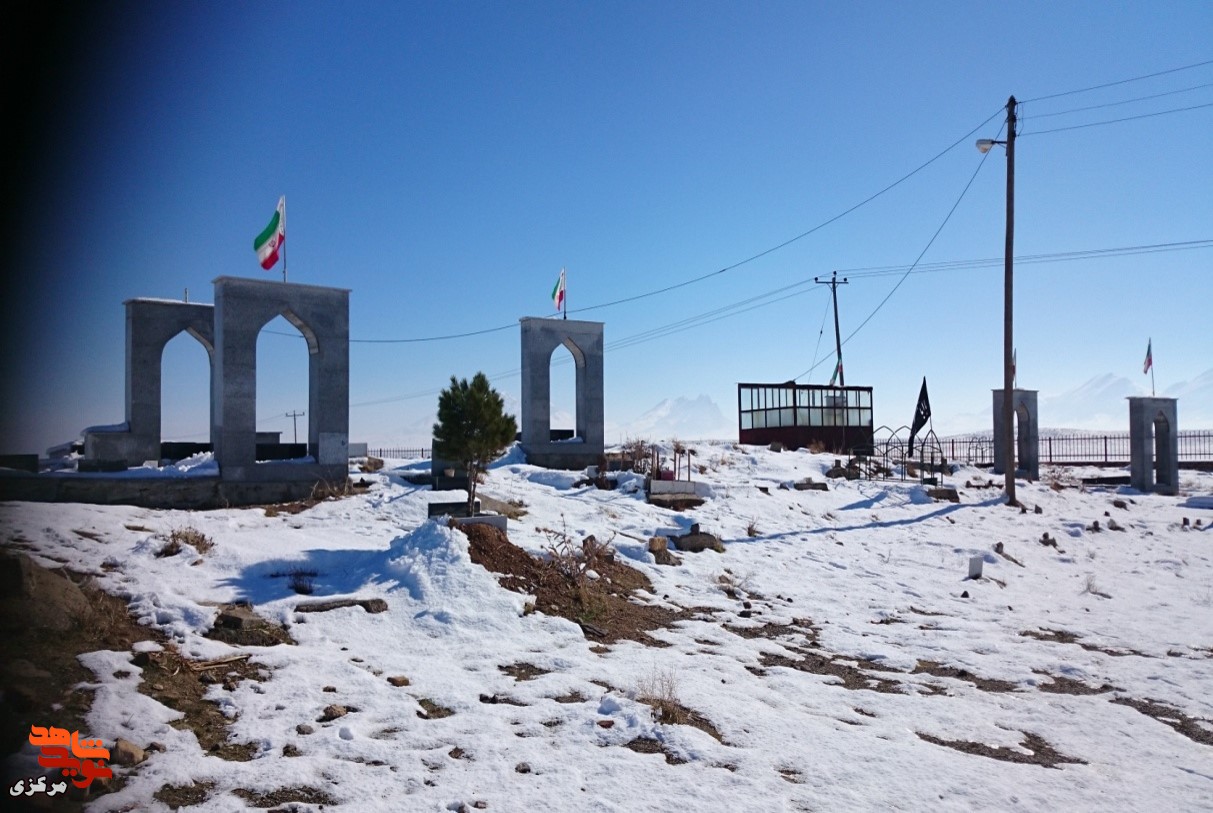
left=0, top=443, right=1213, bottom=812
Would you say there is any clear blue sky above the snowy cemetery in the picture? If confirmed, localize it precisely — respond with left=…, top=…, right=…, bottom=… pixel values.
left=0, top=1, right=1213, bottom=451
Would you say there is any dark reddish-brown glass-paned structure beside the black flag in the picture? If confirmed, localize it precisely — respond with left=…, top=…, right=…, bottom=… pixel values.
left=738, top=381, right=872, bottom=454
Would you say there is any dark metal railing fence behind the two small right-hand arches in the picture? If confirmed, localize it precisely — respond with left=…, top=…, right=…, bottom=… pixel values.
left=912, top=430, right=1213, bottom=466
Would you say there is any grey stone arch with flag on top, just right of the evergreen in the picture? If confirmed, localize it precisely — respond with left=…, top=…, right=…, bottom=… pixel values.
left=520, top=317, right=605, bottom=468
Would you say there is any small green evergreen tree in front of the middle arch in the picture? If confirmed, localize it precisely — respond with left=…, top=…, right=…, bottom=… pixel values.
left=434, top=373, right=518, bottom=517
